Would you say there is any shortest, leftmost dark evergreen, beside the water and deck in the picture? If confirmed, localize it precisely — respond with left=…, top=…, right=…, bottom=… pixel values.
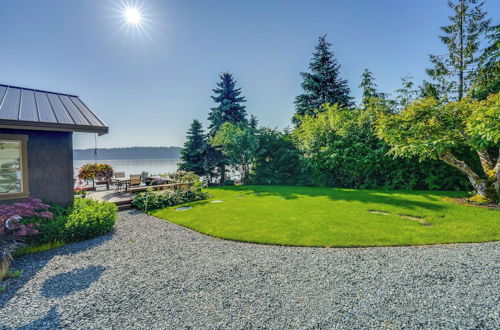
left=179, top=119, right=207, bottom=175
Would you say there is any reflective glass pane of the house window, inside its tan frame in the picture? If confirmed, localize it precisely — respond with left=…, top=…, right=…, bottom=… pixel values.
left=0, top=140, right=22, bottom=194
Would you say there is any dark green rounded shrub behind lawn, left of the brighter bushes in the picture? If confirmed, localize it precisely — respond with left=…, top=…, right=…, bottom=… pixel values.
left=251, top=127, right=311, bottom=185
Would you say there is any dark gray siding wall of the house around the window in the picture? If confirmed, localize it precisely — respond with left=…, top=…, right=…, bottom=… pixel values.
left=0, top=128, right=73, bottom=206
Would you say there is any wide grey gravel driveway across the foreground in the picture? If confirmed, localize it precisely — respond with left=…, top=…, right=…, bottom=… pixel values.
left=0, top=211, right=500, bottom=329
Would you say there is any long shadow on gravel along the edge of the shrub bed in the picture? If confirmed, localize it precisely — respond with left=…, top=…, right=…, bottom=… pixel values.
left=0, top=231, right=114, bottom=308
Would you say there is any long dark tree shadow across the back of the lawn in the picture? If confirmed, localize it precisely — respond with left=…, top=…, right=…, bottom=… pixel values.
left=218, top=186, right=445, bottom=211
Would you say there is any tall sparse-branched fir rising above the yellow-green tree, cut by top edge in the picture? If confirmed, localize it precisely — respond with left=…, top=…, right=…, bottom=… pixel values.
left=427, top=0, right=491, bottom=100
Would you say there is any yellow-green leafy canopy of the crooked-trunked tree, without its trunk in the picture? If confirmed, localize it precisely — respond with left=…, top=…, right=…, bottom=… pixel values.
left=377, top=93, right=500, bottom=159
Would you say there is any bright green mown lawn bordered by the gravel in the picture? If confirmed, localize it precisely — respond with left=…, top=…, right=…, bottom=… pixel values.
left=151, top=186, right=500, bottom=247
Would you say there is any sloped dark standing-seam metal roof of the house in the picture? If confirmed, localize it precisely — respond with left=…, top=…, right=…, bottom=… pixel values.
left=0, top=84, right=109, bottom=135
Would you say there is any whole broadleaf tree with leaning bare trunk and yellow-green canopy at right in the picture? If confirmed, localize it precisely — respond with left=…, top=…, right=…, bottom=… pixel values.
left=377, top=93, right=500, bottom=201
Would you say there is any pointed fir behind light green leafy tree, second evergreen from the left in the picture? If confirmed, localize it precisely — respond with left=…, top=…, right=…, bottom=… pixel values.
left=205, top=72, right=247, bottom=184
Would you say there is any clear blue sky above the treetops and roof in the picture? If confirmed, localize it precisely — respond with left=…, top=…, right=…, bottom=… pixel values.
left=0, top=0, right=500, bottom=148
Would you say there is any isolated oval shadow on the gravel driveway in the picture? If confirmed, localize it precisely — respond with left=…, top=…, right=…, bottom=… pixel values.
left=42, top=266, right=106, bottom=298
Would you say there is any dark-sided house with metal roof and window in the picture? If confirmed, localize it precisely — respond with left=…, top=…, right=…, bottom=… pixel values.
left=0, top=84, right=108, bottom=206
